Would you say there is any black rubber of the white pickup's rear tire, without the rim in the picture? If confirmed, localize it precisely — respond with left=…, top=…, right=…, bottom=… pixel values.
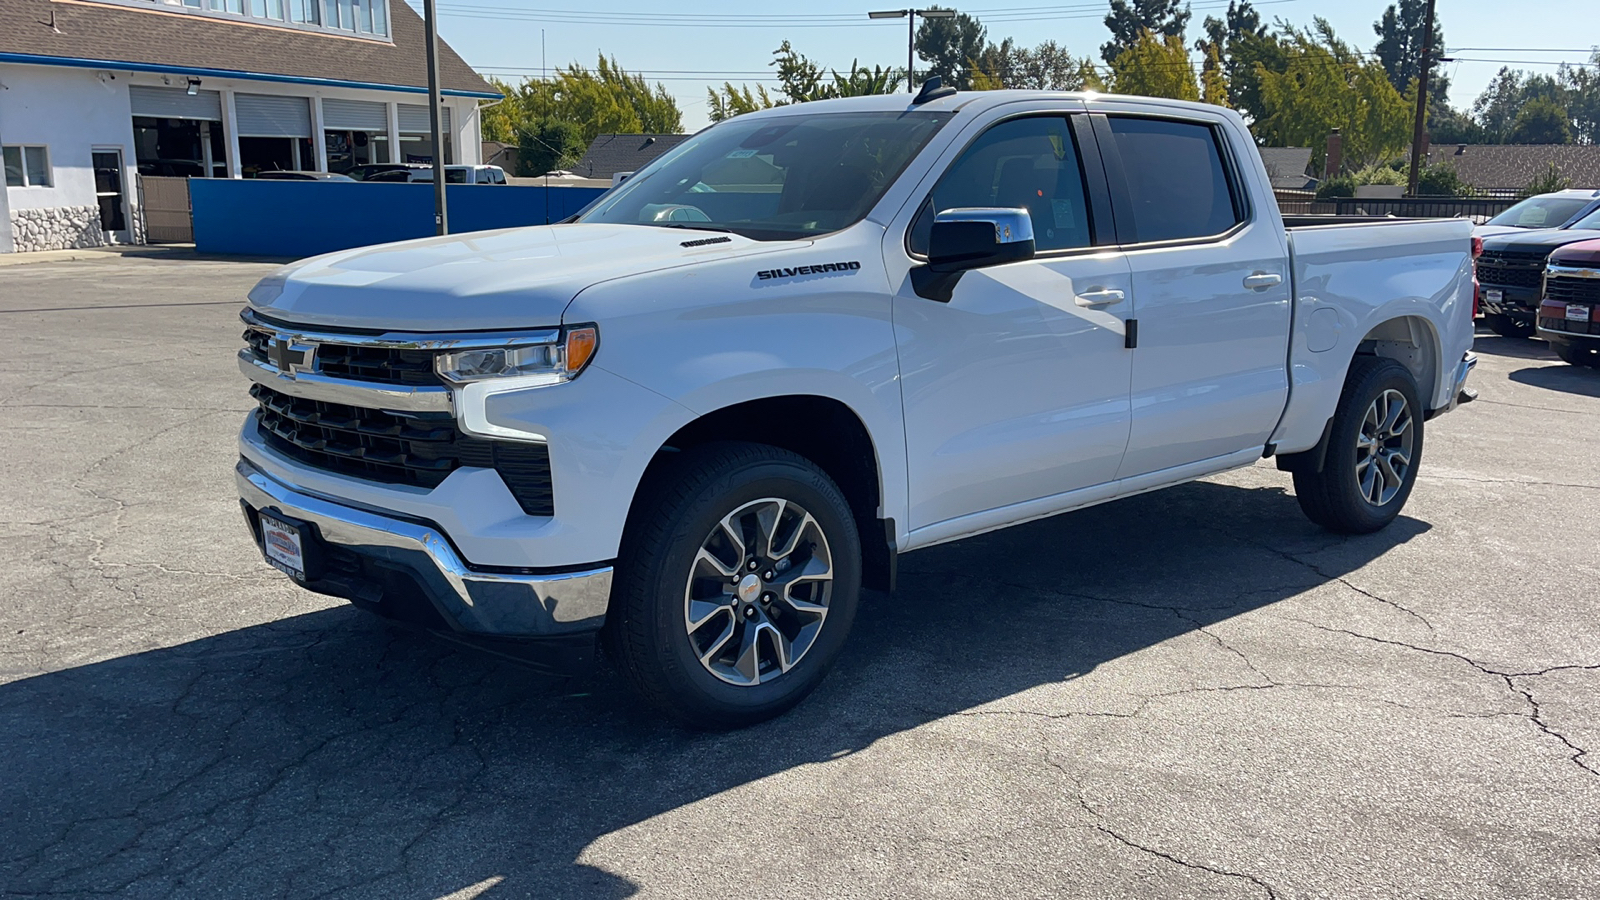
left=1294, top=356, right=1422, bottom=535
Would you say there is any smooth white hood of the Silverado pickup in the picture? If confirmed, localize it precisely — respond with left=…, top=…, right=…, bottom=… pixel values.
left=250, top=224, right=808, bottom=331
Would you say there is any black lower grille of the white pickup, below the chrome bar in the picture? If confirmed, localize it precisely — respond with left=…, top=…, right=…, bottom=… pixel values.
left=250, top=384, right=555, bottom=516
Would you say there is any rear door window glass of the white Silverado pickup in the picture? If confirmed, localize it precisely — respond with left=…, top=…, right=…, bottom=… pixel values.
left=1110, top=117, right=1243, bottom=243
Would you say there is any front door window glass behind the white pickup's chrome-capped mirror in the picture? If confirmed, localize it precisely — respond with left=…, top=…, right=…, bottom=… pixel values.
left=910, top=115, right=1093, bottom=255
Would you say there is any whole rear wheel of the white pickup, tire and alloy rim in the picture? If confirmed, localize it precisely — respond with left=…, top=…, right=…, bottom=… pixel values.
left=1294, top=356, right=1422, bottom=535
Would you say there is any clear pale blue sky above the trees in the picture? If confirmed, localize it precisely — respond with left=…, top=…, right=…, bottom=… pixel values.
left=408, top=0, right=1600, bottom=131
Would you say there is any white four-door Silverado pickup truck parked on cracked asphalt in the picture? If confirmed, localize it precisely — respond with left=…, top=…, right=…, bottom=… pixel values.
left=237, top=88, right=1475, bottom=727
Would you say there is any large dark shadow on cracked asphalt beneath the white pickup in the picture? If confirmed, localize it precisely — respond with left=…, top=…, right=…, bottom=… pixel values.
left=0, top=482, right=1427, bottom=898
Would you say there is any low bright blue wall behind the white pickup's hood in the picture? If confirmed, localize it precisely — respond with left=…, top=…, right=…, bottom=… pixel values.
left=189, top=178, right=602, bottom=258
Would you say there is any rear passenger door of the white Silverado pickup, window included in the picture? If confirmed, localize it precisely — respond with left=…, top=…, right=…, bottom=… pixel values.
left=1091, top=102, right=1290, bottom=479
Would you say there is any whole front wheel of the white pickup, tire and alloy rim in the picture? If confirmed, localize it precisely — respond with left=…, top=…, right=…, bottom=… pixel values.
left=606, top=444, right=861, bottom=729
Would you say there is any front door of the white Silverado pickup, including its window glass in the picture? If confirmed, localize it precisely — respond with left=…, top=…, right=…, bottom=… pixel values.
left=894, top=115, right=1133, bottom=530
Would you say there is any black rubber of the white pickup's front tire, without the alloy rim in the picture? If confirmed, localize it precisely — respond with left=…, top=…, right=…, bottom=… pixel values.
left=606, top=442, right=861, bottom=730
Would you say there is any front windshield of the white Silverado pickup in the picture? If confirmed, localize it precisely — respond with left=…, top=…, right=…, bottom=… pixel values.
left=578, top=112, right=950, bottom=240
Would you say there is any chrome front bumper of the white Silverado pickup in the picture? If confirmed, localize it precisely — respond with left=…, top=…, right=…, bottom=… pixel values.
left=234, top=460, right=611, bottom=637
